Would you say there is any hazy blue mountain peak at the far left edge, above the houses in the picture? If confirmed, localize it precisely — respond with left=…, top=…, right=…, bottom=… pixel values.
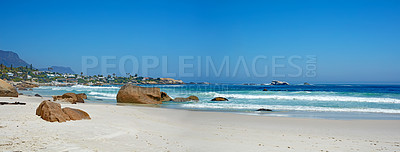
left=0, top=50, right=29, bottom=67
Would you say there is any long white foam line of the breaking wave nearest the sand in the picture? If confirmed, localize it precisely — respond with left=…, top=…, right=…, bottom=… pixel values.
left=181, top=103, right=400, bottom=114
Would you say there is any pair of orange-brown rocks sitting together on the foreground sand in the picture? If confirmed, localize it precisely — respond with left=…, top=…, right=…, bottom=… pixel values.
left=36, top=100, right=91, bottom=122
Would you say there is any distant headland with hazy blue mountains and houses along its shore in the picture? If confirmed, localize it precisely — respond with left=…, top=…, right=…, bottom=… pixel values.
left=0, top=50, right=188, bottom=86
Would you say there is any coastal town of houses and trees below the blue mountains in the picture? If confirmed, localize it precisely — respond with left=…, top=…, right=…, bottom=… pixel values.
left=0, top=64, right=184, bottom=86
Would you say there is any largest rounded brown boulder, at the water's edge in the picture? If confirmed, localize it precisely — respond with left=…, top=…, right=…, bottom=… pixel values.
left=117, top=84, right=162, bottom=104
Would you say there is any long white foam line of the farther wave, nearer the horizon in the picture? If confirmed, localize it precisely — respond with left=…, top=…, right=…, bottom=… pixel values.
left=214, top=93, right=400, bottom=103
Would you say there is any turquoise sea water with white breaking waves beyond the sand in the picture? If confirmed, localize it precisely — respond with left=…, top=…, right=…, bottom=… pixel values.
left=23, top=84, right=400, bottom=119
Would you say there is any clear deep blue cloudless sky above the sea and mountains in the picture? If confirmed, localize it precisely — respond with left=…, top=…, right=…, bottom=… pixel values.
left=0, top=0, right=400, bottom=83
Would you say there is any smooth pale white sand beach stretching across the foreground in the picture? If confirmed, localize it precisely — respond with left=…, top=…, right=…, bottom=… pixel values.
left=0, top=96, right=400, bottom=152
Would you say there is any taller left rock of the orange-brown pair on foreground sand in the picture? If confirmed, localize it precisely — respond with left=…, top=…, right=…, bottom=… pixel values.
left=36, top=100, right=70, bottom=122
